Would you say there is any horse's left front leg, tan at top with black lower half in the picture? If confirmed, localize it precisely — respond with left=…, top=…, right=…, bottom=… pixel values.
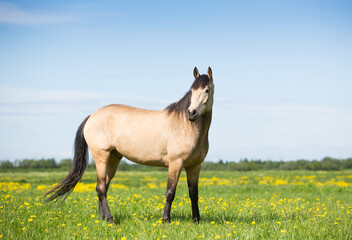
left=163, top=161, right=182, bottom=222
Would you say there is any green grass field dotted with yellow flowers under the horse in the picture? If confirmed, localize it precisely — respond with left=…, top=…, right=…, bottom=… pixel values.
left=0, top=171, right=352, bottom=239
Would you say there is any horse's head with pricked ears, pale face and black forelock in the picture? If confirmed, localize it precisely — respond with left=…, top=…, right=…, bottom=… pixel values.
left=186, top=67, right=214, bottom=121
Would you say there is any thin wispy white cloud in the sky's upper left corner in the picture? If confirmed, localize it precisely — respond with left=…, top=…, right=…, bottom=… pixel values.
left=0, top=2, right=77, bottom=24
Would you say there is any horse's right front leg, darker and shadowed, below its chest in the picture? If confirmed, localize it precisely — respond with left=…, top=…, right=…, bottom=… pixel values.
left=186, top=164, right=200, bottom=222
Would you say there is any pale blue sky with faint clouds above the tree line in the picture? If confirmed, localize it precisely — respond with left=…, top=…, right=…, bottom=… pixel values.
left=0, top=0, right=352, bottom=161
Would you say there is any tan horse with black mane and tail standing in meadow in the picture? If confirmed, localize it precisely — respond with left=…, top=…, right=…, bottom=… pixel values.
left=44, top=67, right=214, bottom=223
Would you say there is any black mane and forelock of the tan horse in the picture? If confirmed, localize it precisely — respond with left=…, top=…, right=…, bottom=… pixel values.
left=165, top=75, right=210, bottom=115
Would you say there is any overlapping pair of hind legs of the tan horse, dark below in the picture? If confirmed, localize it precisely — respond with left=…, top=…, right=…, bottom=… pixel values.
left=92, top=151, right=121, bottom=222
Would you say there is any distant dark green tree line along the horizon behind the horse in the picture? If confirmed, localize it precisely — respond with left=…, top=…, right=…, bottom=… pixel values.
left=0, top=157, right=352, bottom=171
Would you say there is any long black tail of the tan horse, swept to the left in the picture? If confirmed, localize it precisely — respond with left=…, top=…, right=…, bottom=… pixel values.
left=44, top=116, right=89, bottom=203
